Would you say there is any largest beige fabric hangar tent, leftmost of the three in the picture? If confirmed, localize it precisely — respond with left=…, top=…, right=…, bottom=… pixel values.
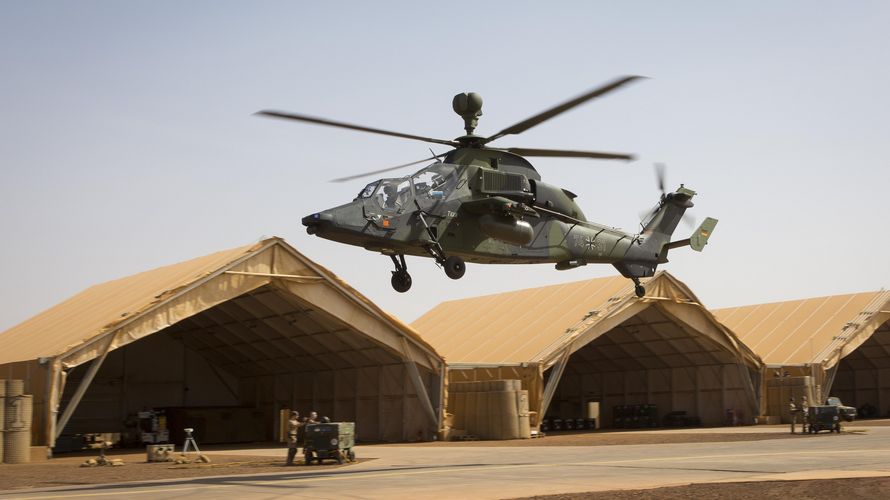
left=0, top=238, right=444, bottom=452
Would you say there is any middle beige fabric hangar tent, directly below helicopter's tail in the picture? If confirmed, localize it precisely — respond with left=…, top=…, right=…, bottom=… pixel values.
left=412, top=272, right=761, bottom=426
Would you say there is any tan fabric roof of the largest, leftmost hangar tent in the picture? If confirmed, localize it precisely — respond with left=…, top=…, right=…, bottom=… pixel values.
left=0, top=238, right=441, bottom=365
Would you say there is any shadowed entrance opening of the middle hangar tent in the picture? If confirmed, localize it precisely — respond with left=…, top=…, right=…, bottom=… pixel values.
left=545, top=304, right=760, bottom=429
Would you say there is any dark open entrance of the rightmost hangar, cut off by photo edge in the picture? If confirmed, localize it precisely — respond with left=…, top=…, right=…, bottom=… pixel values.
left=831, top=321, right=890, bottom=418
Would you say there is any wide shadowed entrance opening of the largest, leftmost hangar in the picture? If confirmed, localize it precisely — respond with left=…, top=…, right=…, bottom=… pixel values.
left=62, top=285, right=440, bottom=444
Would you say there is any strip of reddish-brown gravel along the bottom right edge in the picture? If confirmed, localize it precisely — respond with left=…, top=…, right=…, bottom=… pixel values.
left=512, top=477, right=890, bottom=500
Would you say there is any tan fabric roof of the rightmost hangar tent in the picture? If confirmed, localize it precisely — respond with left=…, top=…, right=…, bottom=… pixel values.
left=714, top=291, right=890, bottom=368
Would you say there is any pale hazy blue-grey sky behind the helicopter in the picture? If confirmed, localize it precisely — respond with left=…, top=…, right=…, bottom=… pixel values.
left=0, top=0, right=890, bottom=331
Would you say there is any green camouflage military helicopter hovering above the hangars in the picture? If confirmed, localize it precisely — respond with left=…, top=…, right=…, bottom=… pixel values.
left=257, top=76, right=717, bottom=297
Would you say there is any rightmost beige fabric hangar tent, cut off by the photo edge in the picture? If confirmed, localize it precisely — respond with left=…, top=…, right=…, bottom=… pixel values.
left=714, top=291, right=890, bottom=416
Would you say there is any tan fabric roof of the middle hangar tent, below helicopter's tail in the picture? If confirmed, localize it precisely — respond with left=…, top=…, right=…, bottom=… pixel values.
left=412, top=272, right=760, bottom=366
